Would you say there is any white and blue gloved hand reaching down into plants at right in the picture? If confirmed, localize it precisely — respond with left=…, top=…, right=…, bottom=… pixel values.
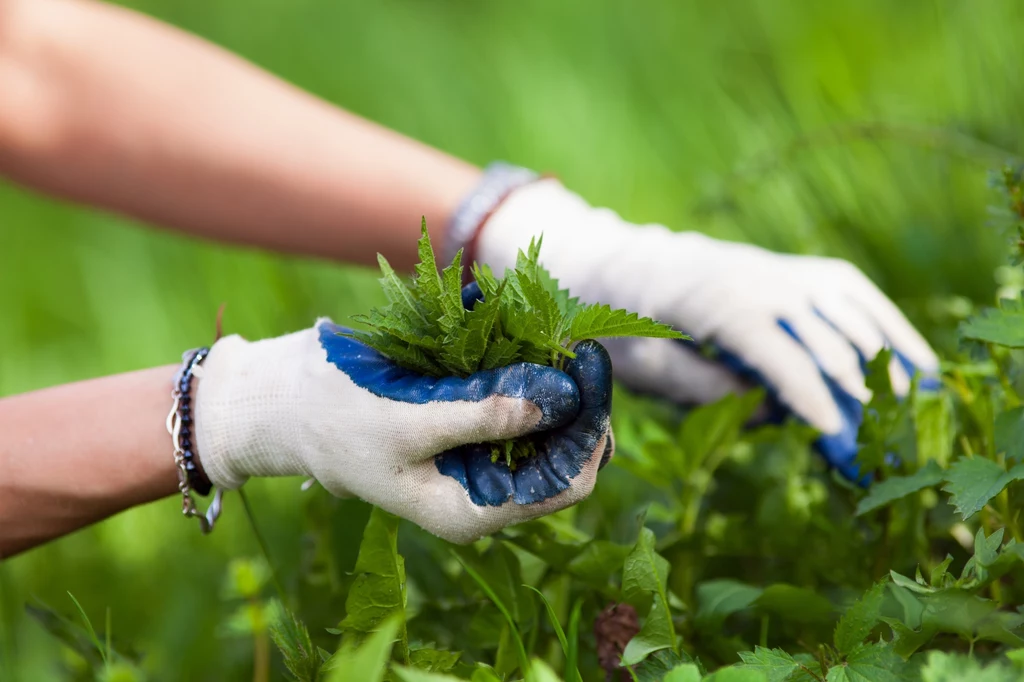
left=468, top=179, right=938, bottom=479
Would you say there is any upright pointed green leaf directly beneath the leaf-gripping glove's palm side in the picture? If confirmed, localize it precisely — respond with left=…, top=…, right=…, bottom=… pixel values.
left=339, top=507, right=409, bottom=664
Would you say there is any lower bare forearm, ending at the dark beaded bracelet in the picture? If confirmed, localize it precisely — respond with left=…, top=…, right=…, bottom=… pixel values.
left=0, top=366, right=177, bottom=558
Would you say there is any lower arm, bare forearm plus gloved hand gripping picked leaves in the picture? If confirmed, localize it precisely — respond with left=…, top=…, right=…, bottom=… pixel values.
left=0, top=321, right=613, bottom=558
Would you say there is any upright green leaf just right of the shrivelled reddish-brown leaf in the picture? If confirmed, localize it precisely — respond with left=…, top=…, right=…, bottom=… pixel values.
left=623, top=527, right=676, bottom=666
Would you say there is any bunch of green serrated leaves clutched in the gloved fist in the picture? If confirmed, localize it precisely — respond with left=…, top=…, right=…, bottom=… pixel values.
left=345, top=220, right=687, bottom=466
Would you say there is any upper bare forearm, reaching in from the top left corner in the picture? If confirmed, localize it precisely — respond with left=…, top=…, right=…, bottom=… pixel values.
left=0, top=0, right=478, bottom=265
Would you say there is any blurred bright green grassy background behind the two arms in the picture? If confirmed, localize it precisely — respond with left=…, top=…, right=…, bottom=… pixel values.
left=0, top=0, right=1024, bottom=680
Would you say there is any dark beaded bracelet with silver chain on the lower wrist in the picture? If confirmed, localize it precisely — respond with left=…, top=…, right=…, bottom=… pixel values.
left=167, top=347, right=223, bottom=534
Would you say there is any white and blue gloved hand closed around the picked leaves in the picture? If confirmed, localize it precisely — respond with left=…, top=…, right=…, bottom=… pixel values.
left=196, top=319, right=613, bottom=543
